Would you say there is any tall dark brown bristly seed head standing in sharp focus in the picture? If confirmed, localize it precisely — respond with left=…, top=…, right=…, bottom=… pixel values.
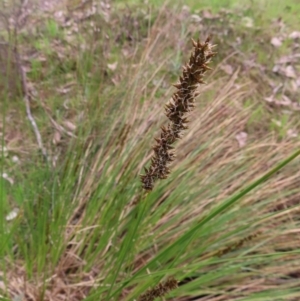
left=141, top=38, right=216, bottom=191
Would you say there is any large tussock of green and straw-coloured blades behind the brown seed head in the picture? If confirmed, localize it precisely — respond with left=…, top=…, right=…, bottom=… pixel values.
left=0, top=2, right=300, bottom=301
